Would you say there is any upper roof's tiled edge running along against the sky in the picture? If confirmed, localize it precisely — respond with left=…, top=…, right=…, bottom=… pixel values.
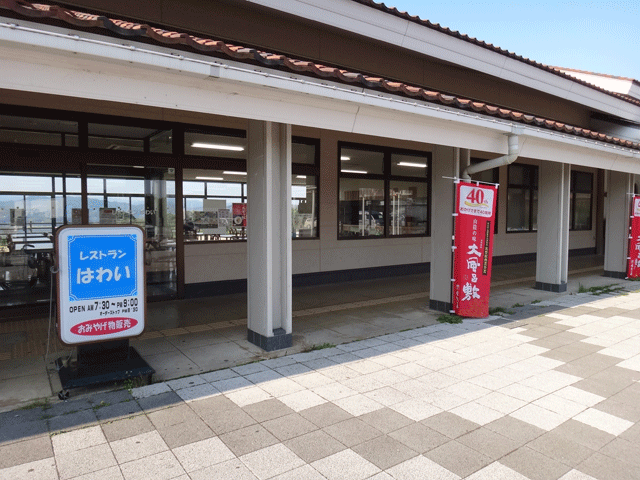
left=351, top=0, right=640, bottom=105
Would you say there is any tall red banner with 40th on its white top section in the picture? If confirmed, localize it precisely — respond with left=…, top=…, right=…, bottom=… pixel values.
left=453, top=182, right=498, bottom=318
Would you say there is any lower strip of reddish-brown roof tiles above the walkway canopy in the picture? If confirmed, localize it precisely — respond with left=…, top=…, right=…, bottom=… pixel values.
left=0, top=0, right=640, bottom=150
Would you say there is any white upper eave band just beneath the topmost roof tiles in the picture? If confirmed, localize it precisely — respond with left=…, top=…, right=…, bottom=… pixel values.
left=247, top=0, right=640, bottom=122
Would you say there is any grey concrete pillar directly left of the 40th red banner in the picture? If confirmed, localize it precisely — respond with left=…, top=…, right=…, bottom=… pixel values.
left=429, top=146, right=460, bottom=313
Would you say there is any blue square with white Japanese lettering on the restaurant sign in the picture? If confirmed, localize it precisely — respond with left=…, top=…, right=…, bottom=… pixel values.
left=67, top=234, right=139, bottom=302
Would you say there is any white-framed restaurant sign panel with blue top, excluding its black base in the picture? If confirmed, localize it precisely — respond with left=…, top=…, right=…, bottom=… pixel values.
left=56, top=225, right=146, bottom=345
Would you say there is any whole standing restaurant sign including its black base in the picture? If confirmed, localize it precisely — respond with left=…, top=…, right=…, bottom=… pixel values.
left=55, top=225, right=155, bottom=399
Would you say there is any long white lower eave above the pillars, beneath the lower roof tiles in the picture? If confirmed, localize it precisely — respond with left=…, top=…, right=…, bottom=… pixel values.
left=0, top=23, right=640, bottom=174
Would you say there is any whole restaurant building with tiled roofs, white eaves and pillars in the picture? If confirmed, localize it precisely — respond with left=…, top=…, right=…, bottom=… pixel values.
left=0, top=0, right=640, bottom=350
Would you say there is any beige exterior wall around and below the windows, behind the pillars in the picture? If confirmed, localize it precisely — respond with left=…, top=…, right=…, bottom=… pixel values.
left=178, top=118, right=597, bottom=284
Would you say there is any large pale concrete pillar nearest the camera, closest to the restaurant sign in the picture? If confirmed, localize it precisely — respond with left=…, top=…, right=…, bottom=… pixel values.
left=247, top=120, right=292, bottom=351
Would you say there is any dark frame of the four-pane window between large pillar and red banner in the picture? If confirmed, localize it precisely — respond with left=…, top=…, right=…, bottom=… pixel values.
left=336, top=141, right=433, bottom=240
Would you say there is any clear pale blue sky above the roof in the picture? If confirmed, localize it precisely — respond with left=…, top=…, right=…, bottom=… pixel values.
left=377, top=0, right=640, bottom=81
